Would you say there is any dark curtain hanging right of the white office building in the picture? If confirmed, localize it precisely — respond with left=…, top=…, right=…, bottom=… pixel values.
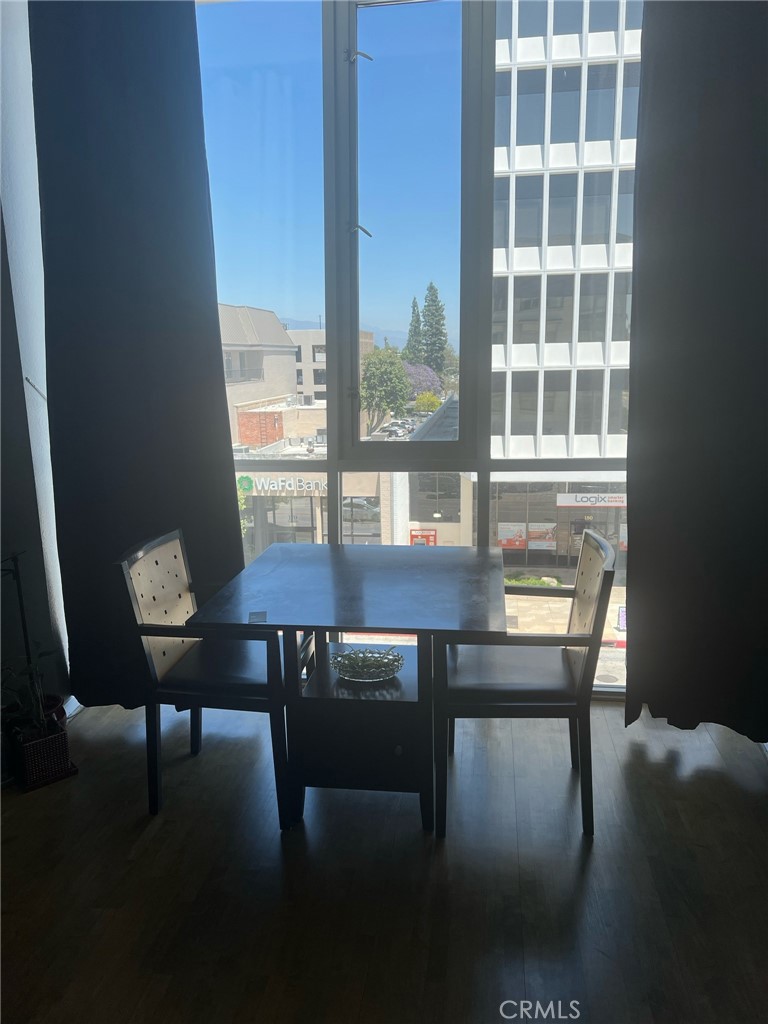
left=627, top=2, right=768, bottom=740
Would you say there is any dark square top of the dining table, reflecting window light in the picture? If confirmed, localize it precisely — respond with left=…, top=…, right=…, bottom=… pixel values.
left=187, top=544, right=507, bottom=642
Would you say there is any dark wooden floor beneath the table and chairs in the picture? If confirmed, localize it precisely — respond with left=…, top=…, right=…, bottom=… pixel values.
left=2, top=705, right=768, bottom=1024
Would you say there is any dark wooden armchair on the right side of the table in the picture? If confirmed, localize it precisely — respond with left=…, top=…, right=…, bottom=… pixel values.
left=434, top=529, right=614, bottom=837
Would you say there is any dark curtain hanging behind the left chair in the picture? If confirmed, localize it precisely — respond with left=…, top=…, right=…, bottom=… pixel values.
left=30, top=0, right=243, bottom=707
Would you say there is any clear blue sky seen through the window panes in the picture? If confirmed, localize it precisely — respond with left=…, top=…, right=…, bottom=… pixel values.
left=197, top=0, right=461, bottom=345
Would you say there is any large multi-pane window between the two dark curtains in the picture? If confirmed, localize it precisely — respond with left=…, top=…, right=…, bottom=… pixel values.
left=197, top=0, right=640, bottom=688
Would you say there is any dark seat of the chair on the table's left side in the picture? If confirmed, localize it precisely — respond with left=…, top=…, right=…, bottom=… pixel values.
left=160, top=639, right=268, bottom=697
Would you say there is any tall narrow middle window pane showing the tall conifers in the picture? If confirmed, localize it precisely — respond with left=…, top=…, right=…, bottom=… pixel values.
left=358, top=3, right=460, bottom=444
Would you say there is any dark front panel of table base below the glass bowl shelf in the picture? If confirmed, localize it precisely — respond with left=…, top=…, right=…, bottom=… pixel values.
left=288, top=700, right=432, bottom=793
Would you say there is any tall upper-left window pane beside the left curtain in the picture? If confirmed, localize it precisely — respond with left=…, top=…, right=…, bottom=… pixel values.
left=195, top=0, right=326, bottom=456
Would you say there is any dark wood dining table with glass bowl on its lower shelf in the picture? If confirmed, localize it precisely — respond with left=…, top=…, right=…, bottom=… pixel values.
left=187, top=544, right=507, bottom=829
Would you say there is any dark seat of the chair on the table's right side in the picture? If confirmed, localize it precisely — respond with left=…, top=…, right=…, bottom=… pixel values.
left=447, top=645, right=575, bottom=705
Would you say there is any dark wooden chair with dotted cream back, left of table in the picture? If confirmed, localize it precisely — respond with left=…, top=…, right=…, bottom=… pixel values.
left=121, top=530, right=293, bottom=828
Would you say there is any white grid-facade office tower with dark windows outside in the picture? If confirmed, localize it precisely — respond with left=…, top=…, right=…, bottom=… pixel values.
left=492, top=0, right=642, bottom=460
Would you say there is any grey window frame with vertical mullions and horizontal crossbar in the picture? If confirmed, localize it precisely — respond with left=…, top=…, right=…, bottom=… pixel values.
left=237, top=0, right=627, bottom=546
